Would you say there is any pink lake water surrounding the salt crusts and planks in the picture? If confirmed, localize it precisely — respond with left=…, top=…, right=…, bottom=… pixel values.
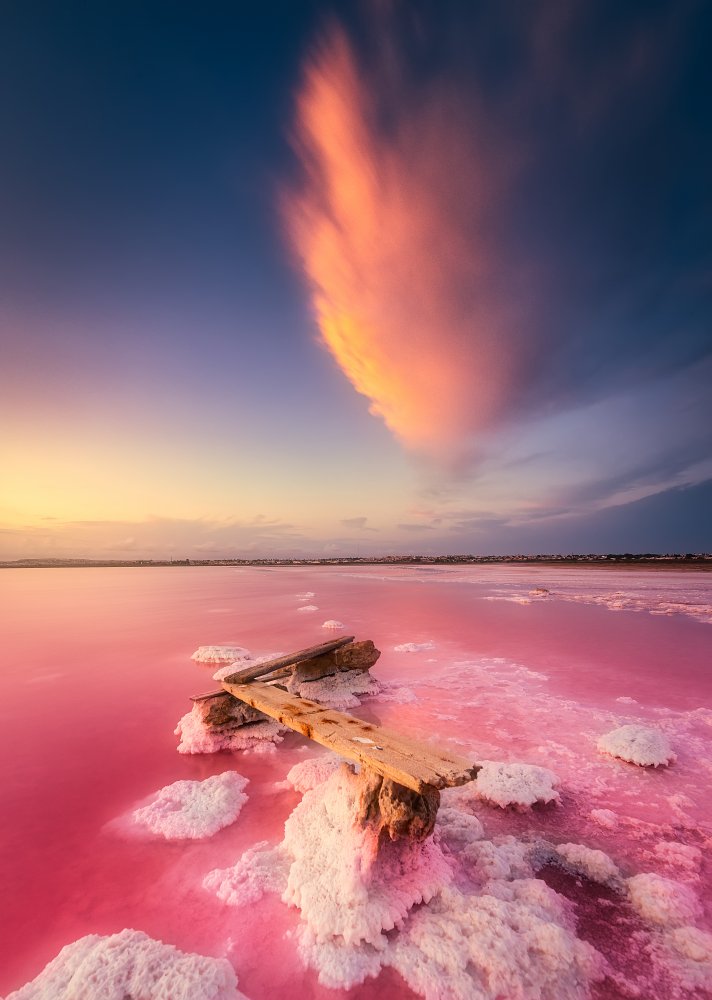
left=0, top=566, right=712, bottom=1000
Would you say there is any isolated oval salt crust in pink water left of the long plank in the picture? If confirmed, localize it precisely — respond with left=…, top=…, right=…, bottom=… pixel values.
left=131, top=771, right=248, bottom=840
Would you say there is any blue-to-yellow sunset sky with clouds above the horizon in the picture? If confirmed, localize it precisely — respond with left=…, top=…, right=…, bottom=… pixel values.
left=0, top=0, right=712, bottom=560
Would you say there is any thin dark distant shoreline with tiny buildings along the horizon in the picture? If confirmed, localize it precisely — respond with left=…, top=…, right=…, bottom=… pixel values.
left=0, top=552, right=712, bottom=570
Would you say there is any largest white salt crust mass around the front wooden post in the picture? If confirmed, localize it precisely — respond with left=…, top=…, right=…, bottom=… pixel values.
left=205, top=758, right=605, bottom=1000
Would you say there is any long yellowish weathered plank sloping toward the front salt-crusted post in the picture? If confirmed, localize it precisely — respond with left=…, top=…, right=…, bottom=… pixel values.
left=222, top=678, right=479, bottom=795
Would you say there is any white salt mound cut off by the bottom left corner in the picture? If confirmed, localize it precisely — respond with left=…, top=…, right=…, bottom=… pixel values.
left=7, top=929, right=247, bottom=1000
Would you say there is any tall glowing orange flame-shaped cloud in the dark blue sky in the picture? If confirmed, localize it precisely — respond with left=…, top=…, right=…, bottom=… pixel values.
left=284, top=18, right=526, bottom=460
